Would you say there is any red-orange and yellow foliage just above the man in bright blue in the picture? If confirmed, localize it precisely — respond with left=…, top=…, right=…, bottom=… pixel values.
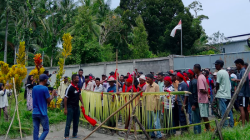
left=29, top=53, right=45, bottom=83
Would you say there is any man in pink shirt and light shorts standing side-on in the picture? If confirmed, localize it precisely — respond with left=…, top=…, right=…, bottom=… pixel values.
left=194, top=64, right=210, bottom=130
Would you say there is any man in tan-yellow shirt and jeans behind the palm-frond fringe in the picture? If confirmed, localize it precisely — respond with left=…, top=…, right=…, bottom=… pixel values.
left=145, top=74, right=162, bottom=139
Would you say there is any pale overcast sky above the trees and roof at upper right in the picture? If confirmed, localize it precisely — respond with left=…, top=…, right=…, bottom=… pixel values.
left=111, top=0, right=250, bottom=37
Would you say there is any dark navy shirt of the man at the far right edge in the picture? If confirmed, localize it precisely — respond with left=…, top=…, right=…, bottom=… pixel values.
left=238, top=68, right=250, bottom=97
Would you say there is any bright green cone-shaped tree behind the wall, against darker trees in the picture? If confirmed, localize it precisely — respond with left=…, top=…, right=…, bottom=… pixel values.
left=129, top=15, right=152, bottom=59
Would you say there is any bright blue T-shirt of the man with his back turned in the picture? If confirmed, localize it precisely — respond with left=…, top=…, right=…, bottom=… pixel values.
left=32, top=85, right=50, bottom=116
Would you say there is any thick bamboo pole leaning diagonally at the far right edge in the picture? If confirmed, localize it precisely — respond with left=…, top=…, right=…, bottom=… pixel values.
left=211, top=66, right=250, bottom=140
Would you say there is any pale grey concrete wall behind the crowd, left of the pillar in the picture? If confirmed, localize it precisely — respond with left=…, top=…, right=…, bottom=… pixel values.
left=23, top=56, right=173, bottom=86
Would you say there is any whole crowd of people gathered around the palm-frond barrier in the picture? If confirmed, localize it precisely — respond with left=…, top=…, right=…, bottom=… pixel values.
left=0, top=59, right=250, bottom=139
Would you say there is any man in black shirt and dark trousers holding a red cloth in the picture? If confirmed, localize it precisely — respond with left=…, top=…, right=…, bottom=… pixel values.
left=64, top=74, right=83, bottom=140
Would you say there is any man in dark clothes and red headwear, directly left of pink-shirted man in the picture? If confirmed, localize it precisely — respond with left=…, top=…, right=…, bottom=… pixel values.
left=187, top=69, right=201, bottom=134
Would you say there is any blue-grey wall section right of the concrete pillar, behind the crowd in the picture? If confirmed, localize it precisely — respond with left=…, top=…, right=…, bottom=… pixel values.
left=174, top=52, right=250, bottom=71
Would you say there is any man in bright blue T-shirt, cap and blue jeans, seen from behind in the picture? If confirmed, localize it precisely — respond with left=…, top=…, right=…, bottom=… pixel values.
left=32, top=74, right=56, bottom=140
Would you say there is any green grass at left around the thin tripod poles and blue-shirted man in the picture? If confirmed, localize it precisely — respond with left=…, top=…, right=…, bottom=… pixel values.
left=0, top=92, right=66, bottom=138
